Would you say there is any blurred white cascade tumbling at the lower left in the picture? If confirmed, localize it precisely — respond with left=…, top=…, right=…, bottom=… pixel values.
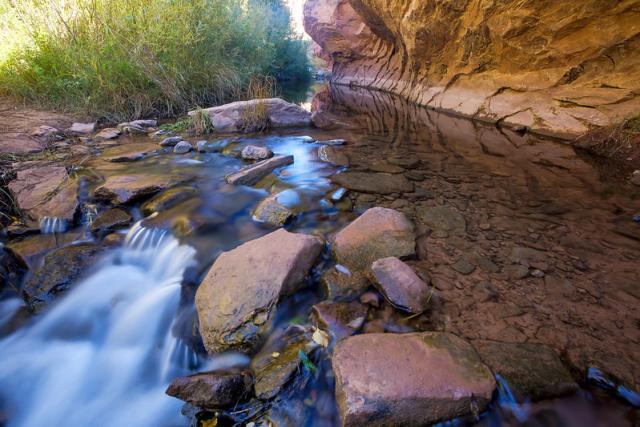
left=0, top=225, right=197, bottom=427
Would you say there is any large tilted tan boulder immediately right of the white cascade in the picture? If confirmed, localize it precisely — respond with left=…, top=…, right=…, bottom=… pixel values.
left=195, top=229, right=323, bottom=353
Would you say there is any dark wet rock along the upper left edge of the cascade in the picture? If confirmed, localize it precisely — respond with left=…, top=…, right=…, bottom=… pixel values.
left=22, top=243, right=102, bottom=305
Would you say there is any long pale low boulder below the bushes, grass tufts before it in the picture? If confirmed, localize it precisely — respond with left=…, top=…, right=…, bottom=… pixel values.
left=189, top=98, right=311, bottom=132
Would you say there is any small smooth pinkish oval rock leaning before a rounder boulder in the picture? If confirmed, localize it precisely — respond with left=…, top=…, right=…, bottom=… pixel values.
left=371, top=257, right=432, bottom=313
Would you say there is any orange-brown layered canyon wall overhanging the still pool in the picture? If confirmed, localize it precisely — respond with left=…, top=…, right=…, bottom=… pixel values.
left=304, top=0, right=640, bottom=138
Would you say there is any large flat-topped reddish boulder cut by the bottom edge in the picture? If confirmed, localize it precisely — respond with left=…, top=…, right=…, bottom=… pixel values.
left=332, top=332, right=496, bottom=427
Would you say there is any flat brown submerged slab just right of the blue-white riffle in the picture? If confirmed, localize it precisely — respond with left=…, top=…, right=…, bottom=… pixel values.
left=331, top=172, right=413, bottom=194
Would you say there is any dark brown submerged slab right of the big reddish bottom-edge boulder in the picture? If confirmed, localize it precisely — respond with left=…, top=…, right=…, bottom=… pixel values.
left=472, top=340, right=578, bottom=402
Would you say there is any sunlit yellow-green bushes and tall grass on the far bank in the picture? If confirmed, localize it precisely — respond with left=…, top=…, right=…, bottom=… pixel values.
left=0, top=0, right=309, bottom=120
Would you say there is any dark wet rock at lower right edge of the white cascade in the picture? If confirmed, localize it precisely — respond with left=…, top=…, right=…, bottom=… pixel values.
left=166, top=371, right=253, bottom=409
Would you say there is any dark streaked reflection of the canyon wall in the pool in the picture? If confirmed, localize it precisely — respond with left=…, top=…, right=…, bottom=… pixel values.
left=312, top=85, right=620, bottom=197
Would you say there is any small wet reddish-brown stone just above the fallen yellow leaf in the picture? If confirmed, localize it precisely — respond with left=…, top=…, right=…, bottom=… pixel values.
left=311, top=301, right=368, bottom=342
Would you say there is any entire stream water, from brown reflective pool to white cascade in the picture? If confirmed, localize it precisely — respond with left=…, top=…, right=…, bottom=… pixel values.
left=0, top=84, right=640, bottom=427
